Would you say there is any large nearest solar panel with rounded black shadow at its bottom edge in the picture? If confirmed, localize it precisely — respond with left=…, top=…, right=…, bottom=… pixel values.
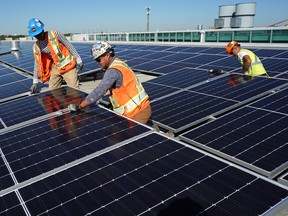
left=0, top=134, right=288, bottom=216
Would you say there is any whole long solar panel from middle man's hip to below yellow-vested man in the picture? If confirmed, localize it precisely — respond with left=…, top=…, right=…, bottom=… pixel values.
left=152, top=74, right=287, bottom=133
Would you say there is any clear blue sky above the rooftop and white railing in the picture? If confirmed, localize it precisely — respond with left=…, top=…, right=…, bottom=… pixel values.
left=0, top=0, right=288, bottom=35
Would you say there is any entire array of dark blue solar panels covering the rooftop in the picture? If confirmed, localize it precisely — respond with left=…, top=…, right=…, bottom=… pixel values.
left=0, top=43, right=288, bottom=216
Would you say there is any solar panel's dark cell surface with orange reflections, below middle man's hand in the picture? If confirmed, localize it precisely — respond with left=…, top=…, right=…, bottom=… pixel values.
left=0, top=103, right=149, bottom=186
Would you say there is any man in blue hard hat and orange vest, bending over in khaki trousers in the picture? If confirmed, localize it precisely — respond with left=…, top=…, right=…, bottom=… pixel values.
left=28, top=18, right=83, bottom=93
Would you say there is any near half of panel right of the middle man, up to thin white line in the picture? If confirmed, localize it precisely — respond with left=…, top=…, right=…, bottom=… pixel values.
left=152, top=91, right=237, bottom=133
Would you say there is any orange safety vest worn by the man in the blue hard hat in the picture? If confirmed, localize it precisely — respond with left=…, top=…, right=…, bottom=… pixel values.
left=33, top=30, right=76, bottom=83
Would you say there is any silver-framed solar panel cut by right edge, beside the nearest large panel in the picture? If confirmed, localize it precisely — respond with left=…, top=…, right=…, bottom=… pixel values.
left=180, top=107, right=288, bottom=178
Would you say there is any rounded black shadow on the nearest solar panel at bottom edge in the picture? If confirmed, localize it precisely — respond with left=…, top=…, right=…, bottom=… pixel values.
left=157, top=197, right=206, bottom=216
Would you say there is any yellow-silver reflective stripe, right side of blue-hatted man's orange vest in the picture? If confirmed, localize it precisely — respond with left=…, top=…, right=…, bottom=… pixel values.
left=48, top=31, right=74, bottom=68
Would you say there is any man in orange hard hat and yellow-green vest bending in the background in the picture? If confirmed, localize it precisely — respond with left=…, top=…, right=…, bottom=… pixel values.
left=226, top=41, right=268, bottom=76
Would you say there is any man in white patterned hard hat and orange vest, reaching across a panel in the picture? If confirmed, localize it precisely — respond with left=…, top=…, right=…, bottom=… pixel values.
left=68, top=41, right=152, bottom=124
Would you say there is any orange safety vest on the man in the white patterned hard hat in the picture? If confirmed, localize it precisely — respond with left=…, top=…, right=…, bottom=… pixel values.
left=108, top=58, right=150, bottom=118
